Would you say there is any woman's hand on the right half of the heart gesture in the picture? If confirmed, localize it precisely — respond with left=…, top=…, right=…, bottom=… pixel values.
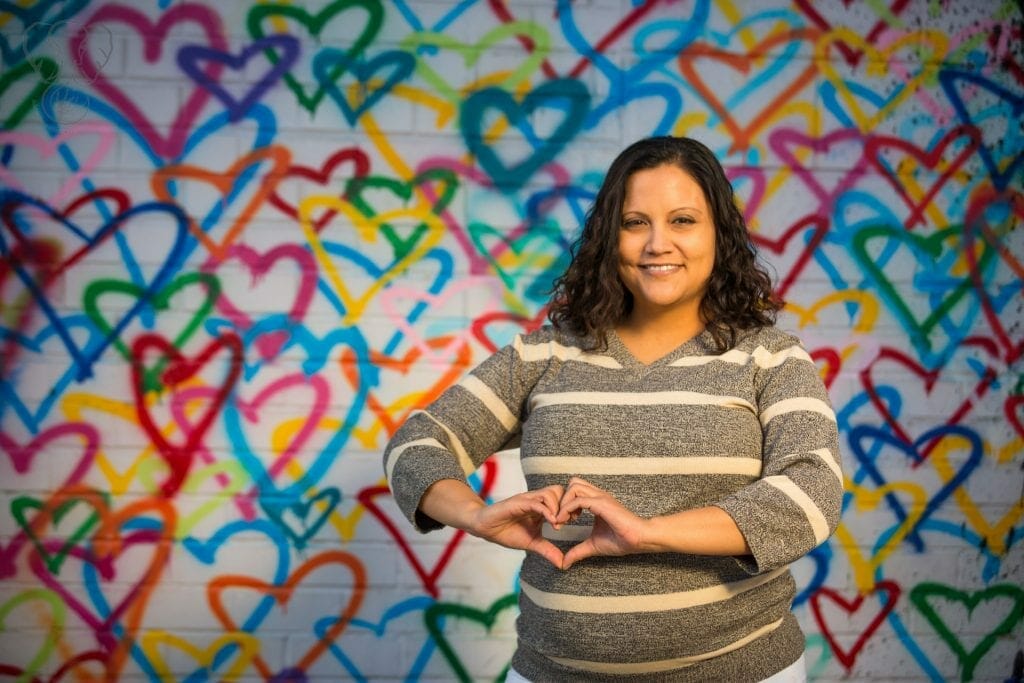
left=556, top=477, right=647, bottom=569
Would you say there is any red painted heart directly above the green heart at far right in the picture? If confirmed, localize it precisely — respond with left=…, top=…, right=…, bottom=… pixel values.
left=865, top=126, right=981, bottom=229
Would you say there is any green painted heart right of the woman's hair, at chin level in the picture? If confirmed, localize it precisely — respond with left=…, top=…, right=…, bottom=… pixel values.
left=852, top=225, right=996, bottom=350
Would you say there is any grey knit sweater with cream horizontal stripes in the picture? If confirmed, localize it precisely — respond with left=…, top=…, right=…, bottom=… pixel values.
left=384, top=327, right=843, bottom=682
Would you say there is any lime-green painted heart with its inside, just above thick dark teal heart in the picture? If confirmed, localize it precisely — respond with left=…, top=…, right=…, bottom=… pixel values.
left=399, top=22, right=551, bottom=107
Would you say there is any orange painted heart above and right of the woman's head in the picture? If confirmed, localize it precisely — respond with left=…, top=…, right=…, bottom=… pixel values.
left=678, top=26, right=820, bottom=152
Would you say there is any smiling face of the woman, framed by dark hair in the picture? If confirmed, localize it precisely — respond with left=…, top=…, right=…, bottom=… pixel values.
left=618, top=165, right=715, bottom=323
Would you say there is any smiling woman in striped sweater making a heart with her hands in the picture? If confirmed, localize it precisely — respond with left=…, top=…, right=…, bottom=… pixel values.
left=384, top=137, right=843, bottom=682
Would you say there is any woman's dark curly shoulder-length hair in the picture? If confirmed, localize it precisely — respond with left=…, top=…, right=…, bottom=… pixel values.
left=548, top=135, right=782, bottom=352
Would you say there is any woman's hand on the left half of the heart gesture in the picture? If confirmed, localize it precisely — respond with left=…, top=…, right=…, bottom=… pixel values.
left=466, top=485, right=564, bottom=568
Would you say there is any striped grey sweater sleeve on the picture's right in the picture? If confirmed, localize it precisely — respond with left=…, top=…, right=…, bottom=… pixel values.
left=718, top=335, right=843, bottom=573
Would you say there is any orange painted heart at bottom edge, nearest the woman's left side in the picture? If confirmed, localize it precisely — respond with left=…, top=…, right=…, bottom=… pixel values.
left=207, top=550, right=367, bottom=681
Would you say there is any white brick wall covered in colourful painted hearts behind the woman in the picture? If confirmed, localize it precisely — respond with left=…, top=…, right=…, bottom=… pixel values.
left=0, top=0, right=1024, bottom=681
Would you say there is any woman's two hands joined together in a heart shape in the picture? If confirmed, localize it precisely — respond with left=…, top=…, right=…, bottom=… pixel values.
left=468, top=476, right=651, bottom=569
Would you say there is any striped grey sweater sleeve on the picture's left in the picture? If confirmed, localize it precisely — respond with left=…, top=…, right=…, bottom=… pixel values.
left=384, top=335, right=541, bottom=532
